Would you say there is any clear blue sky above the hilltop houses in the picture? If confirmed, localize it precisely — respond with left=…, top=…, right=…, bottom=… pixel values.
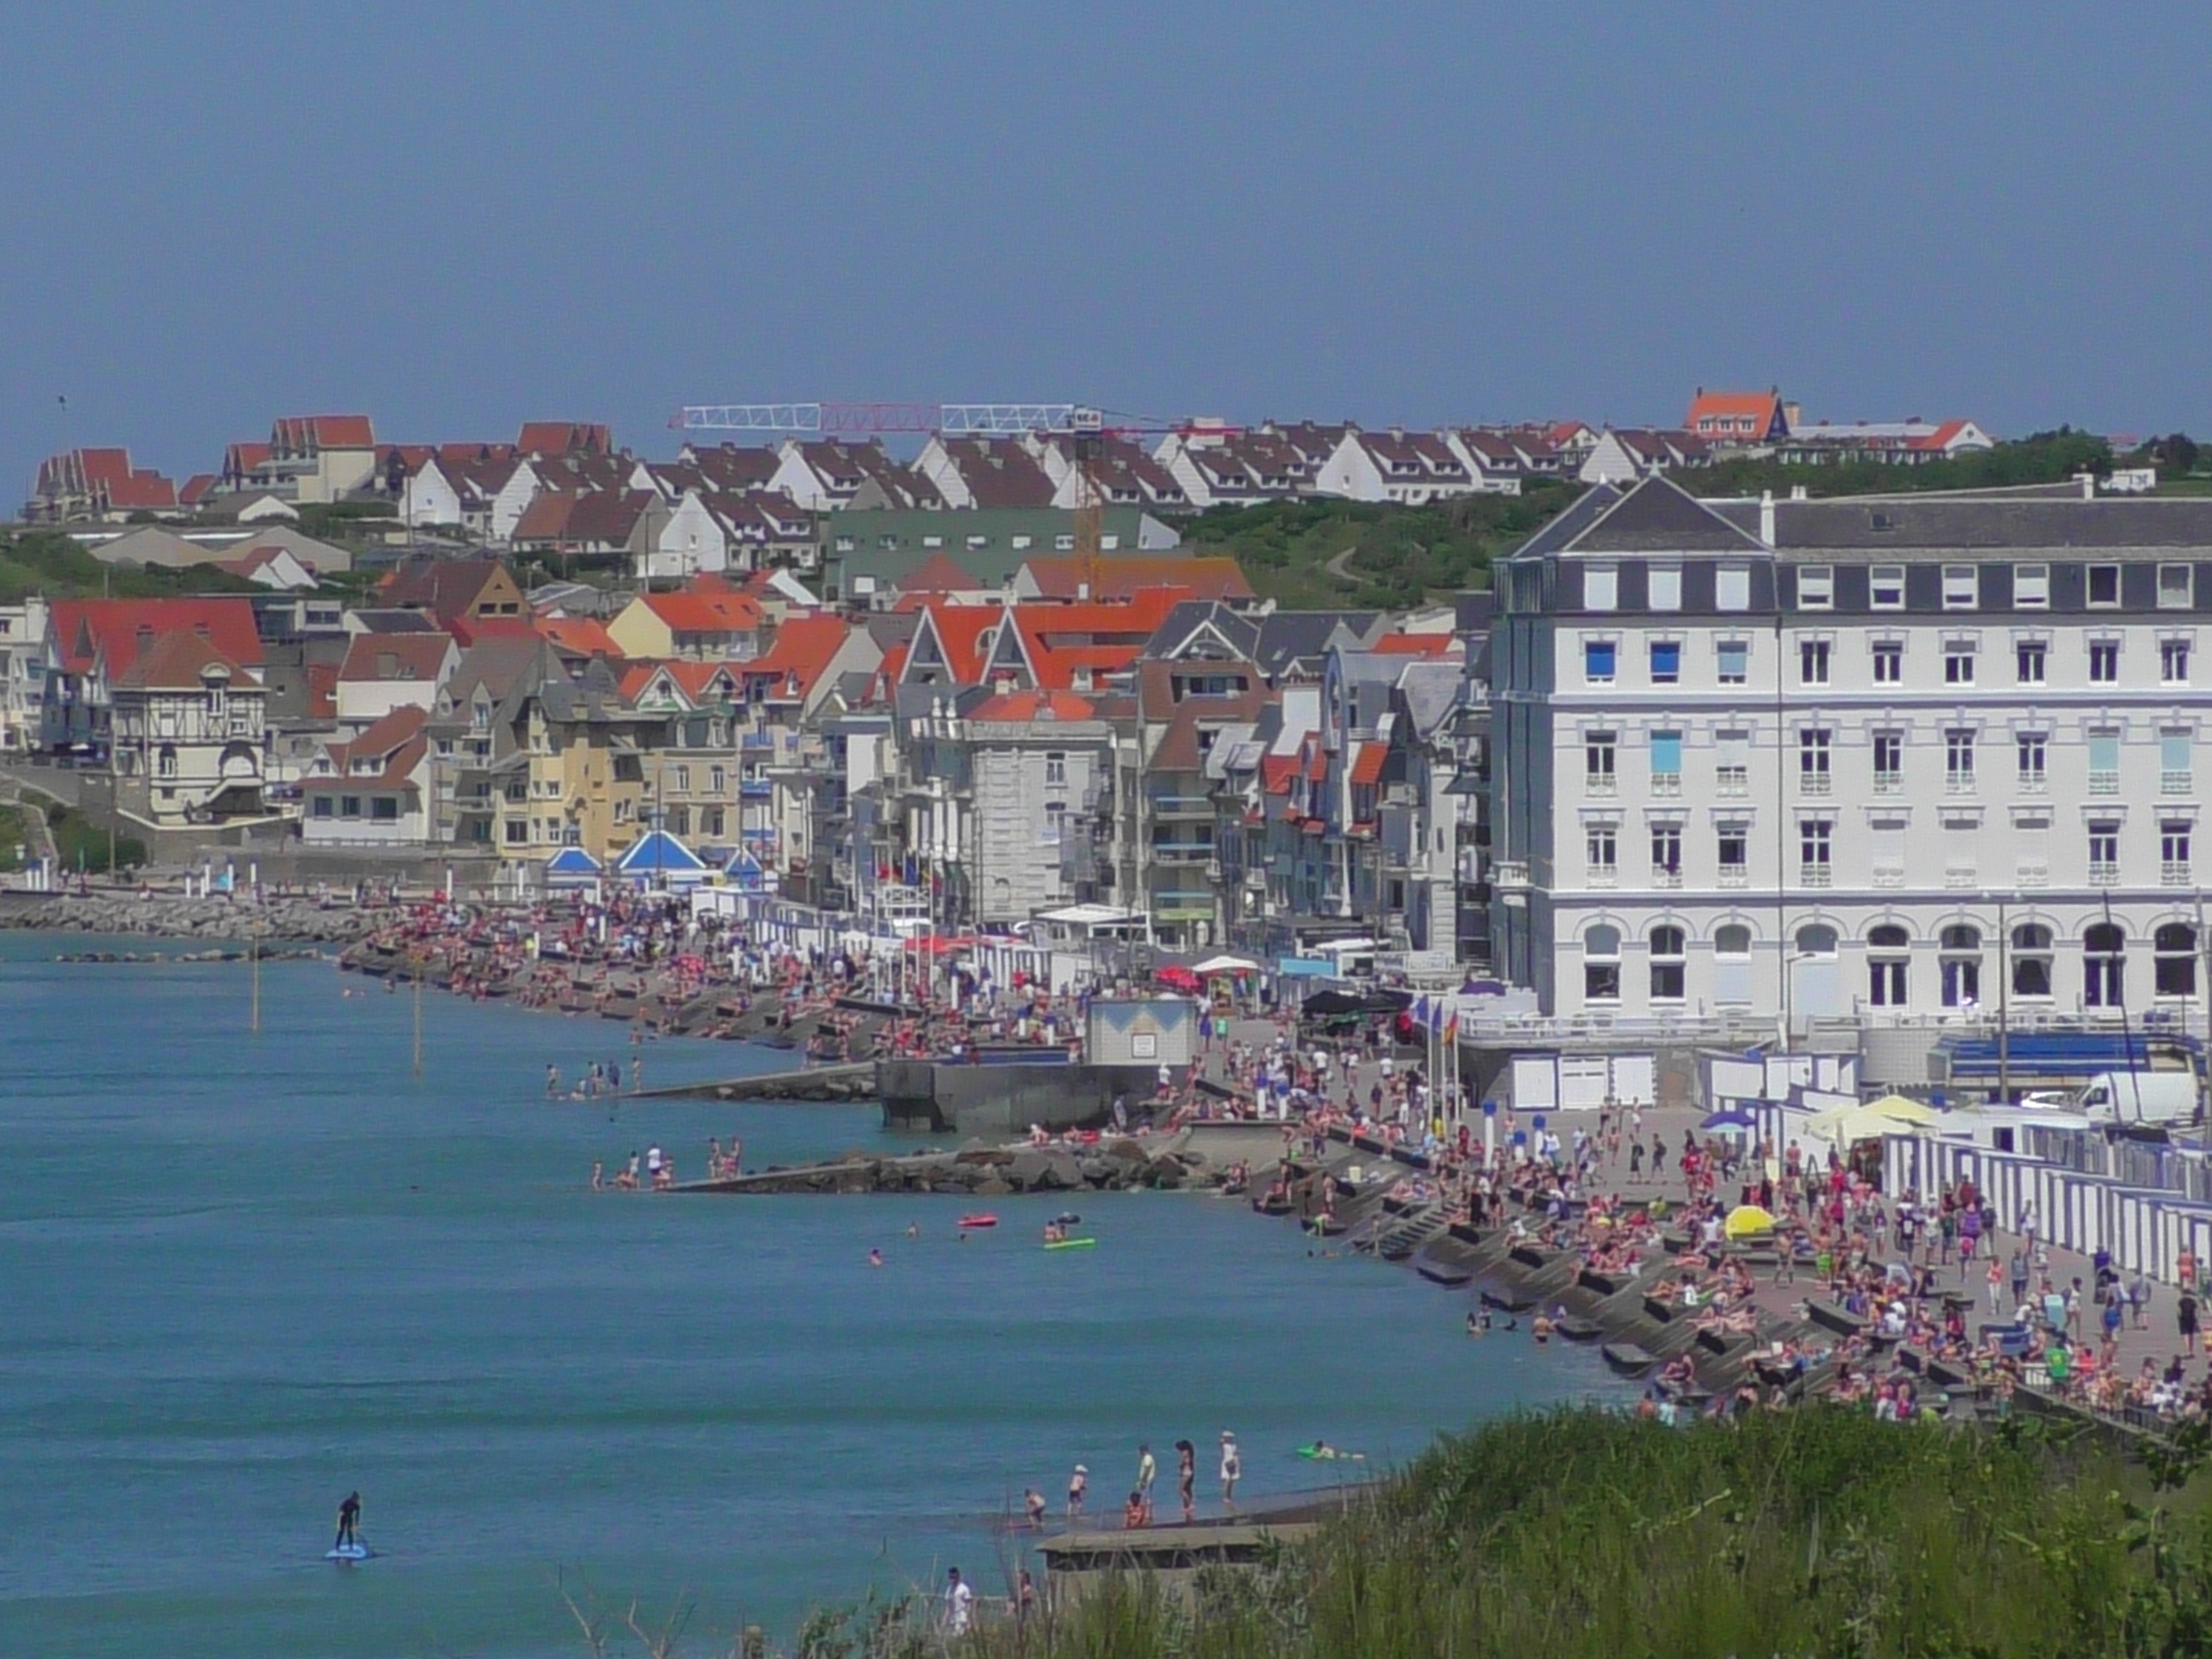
left=0, top=0, right=2212, bottom=491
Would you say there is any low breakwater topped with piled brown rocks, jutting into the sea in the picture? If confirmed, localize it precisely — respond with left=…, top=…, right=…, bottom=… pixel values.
left=677, top=1135, right=1230, bottom=1199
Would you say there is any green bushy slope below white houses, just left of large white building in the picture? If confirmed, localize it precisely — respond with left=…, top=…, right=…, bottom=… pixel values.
left=1181, top=482, right=1582, bottom=609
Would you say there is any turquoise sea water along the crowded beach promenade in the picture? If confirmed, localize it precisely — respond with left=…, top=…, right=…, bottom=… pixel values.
left=0, top=935, right=1615, bottom=1659
